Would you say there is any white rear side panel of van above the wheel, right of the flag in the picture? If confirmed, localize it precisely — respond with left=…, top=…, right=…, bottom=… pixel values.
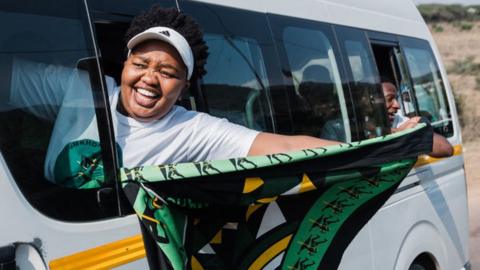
left=368, top=168, right=468, bottom=269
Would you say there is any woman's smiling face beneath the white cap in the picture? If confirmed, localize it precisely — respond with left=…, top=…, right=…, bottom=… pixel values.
left=120, top=40, right=189, bottom=122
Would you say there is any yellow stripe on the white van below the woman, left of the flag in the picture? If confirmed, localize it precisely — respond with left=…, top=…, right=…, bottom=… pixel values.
left=49, top=234, right=145, bottom=270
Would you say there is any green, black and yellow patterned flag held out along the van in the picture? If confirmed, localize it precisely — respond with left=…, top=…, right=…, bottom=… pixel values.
left=121, top=125, right=432, bottom=270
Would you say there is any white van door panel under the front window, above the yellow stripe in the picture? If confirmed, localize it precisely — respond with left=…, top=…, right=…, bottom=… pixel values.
left=0, top=153, right=144, bottom=269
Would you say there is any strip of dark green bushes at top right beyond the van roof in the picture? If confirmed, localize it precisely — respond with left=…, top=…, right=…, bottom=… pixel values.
left=417, top=4, right=480, bottom=22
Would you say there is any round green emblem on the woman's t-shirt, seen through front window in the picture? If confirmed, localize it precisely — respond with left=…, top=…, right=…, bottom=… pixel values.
left=54, top=139, right=105, bottom=188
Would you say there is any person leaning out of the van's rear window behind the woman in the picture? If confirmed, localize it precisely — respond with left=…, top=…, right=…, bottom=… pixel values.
left=381, top=78, right=453, bottom=157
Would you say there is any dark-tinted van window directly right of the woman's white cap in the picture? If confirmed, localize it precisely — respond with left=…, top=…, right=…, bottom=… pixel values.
left=180, top=2, right=273, bottom=131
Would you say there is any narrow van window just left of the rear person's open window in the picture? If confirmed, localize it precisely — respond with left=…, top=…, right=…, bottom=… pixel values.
left=335, top=26, right=389, bottom=140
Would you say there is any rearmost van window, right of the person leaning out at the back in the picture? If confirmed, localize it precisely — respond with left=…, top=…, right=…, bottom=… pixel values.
left=401, top=38, right=453, bottom=137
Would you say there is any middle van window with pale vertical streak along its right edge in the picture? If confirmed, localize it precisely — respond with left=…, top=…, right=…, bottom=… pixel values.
left=282, top=27, right=350, bottom=141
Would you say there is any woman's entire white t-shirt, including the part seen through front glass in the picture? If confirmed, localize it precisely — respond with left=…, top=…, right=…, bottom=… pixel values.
left=9, top=59, right=259, bottom=185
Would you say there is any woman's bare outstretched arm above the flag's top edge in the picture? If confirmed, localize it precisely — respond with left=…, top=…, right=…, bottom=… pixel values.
left=248, top=132, right=340, bottom=156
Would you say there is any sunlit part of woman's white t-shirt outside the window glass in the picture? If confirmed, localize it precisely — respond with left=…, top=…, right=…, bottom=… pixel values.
left=111, top=88, right=258, bottom=168
